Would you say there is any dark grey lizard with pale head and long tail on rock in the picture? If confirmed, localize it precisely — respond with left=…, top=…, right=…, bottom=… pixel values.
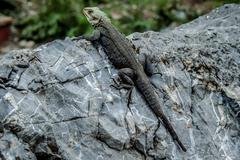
left=73, top=7, right=187, bottom=152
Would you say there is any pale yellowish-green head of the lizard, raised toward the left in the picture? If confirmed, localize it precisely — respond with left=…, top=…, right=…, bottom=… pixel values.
left=83, top=7, right=111, bottom=26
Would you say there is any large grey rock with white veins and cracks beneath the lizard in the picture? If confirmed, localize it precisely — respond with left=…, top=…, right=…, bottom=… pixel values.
left=0, top=4, right=240, bottom=160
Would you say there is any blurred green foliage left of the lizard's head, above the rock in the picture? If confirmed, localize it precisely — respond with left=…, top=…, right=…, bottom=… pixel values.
left=17, top=0, right=90, bottom=41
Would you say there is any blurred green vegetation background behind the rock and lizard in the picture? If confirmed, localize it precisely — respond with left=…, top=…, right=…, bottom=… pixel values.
left=0, top=0, right=240, bottom=43
